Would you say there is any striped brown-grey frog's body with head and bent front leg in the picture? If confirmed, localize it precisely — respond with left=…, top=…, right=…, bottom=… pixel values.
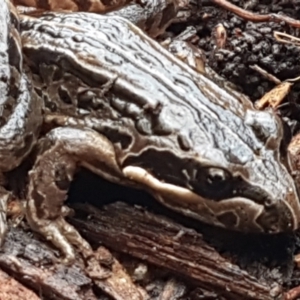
left=0, top=0, right=300, bottom=261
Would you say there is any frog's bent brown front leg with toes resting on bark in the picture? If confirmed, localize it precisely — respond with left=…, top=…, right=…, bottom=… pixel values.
left=26, top=127, right=123, bottom=262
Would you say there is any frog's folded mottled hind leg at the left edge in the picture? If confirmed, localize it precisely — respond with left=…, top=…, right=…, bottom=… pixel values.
left=0, top=2, right=42, bottom=243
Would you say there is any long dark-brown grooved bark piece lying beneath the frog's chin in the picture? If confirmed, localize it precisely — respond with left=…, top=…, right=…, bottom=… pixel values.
left=71, top=202, right=282, bottom=300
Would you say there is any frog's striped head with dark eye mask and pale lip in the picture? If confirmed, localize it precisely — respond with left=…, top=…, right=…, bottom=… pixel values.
left=123, top=109, right=300, bottom=233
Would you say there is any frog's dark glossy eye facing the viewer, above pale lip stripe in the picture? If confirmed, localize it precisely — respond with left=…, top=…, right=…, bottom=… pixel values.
left=191, top=167, right=232, bottom=200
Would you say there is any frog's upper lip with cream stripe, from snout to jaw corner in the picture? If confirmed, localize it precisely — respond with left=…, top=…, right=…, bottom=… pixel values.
left=123, top=166, right=298, bottom=233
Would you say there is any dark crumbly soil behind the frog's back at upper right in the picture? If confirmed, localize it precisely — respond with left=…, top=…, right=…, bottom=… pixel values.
left=171, top=1, right=300, bottom=129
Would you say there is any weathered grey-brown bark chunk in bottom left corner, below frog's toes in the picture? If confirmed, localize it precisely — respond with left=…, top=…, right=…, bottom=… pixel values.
left=0, top=228, right=97, bottom=300
